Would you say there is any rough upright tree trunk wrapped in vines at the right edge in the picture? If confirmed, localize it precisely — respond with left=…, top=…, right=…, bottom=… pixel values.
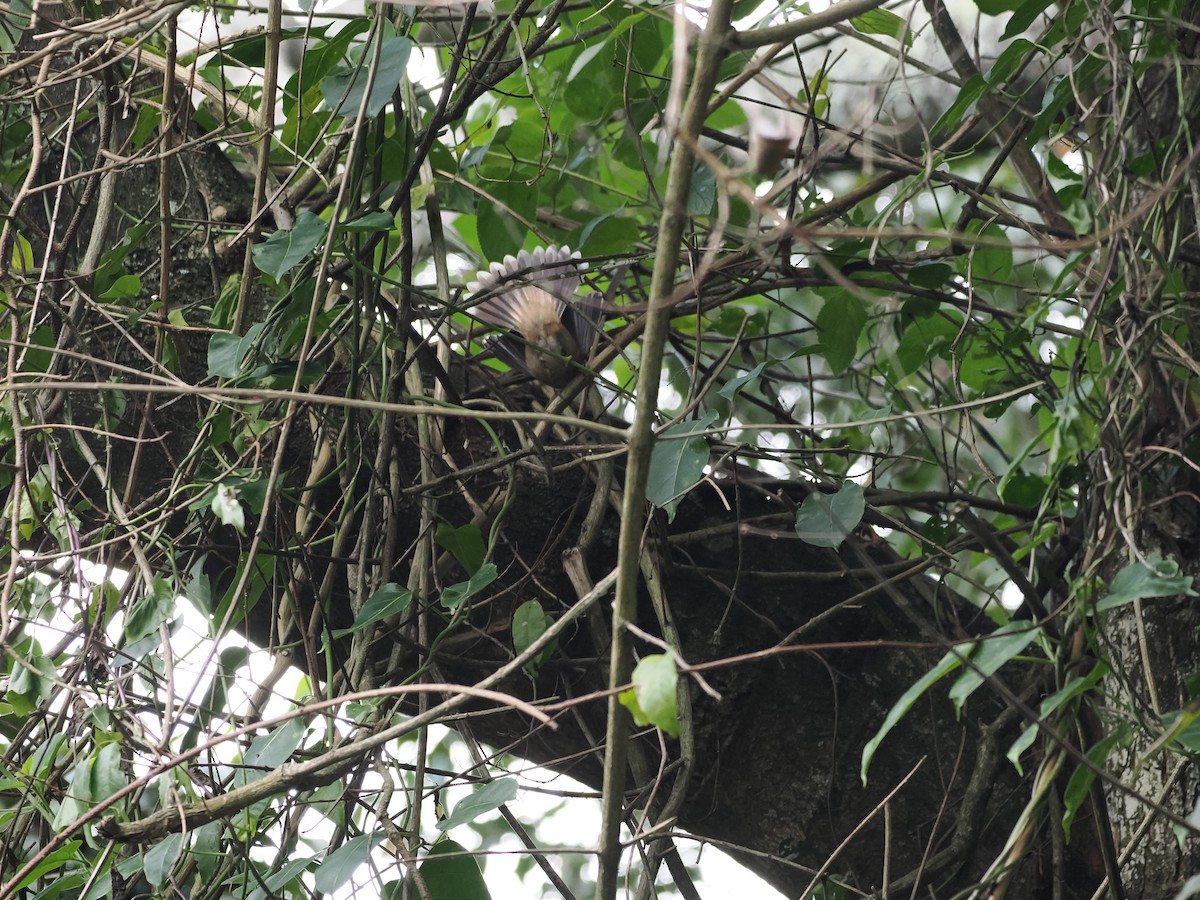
left=1090, top=2, right=1200, bottom=898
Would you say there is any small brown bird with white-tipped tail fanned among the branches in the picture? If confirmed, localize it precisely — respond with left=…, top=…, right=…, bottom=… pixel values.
left=467, top=247, right=602, bottom=388
